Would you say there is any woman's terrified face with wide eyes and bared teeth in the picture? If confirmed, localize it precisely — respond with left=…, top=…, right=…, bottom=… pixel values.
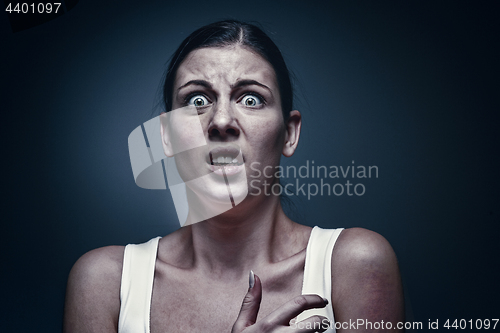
left=166, top=46, right=294, bottom=211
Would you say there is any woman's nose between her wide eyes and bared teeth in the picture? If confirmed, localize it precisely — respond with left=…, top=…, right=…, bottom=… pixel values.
left=208, top=101, right=240, bottom=141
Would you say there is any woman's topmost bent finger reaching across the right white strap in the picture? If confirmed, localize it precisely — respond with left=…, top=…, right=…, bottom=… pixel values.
left=265, top=295, right=328, bottom=325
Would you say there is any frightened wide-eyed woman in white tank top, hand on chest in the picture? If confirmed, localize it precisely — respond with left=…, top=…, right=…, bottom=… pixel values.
left=64, top=21, right=404, bottom=333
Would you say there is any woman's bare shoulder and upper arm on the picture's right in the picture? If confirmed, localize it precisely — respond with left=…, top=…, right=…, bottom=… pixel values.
left=332, top=228, right=404, bottom=325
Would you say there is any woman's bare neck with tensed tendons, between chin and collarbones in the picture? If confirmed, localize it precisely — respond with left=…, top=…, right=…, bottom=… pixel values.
left=186, top=196, right=296, bottom=278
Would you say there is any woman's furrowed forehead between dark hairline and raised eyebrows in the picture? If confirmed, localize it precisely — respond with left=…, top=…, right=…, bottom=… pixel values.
left=174, top=45, right=277, bottom=89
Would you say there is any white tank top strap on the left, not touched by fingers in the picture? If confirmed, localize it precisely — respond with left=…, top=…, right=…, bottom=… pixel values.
left=118, top=237, right=161, bottom=333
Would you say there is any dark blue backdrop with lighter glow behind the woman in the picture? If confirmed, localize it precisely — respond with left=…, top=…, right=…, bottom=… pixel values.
left=0, top=0, right=500, bottom=332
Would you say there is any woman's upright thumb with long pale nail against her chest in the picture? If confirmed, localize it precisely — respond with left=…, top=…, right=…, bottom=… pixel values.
left=231, top=271, right=262, bottom=333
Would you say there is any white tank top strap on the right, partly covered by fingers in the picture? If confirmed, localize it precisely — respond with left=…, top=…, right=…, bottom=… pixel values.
left=297, top=227, right=343, bottom=332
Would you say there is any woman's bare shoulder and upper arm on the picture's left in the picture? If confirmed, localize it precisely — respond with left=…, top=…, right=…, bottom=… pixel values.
left=64, top=246, right=124, bottom=333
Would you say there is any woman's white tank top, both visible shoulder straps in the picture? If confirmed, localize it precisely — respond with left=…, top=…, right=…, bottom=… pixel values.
left=118, top=227, right=343, bottom=333
